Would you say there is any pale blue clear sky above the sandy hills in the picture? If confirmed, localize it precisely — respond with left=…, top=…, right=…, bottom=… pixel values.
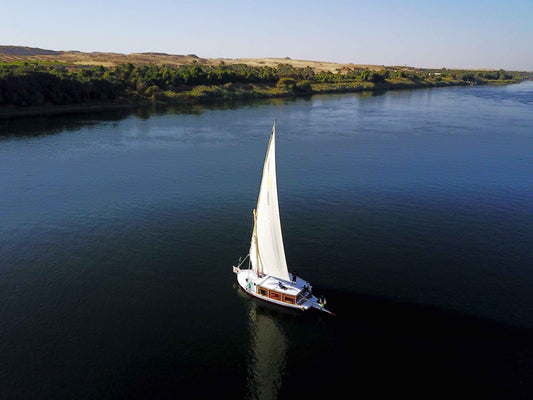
left=0, top=0, right=533, bottom=71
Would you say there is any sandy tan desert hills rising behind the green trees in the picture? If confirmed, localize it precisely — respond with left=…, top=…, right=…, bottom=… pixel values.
left=0, top=46, right=384, bottom=72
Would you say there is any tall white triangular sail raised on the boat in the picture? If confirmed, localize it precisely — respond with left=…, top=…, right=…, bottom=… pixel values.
left=250, top=122, right=289, bottom=280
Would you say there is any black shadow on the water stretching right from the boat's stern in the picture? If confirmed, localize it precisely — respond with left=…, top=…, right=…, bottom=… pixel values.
left=326, top=290, right=533, bottom=399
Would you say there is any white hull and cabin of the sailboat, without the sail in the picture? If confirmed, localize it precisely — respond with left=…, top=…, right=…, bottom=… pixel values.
left=235, top=268, right=331, bottom=314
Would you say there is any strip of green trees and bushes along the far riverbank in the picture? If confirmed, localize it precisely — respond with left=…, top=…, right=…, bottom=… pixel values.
left=0, top=61, right=533, bottom=117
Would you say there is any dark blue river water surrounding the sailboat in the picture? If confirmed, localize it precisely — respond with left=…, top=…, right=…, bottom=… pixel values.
left=0, top=82, right=533, bottom=399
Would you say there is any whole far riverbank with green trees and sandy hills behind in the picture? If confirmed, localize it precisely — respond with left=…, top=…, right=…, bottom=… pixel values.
left=0, top=46, right=533, bottom=119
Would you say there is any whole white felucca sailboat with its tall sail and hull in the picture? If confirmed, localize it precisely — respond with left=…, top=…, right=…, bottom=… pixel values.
left=233, top=122, right=332, bottom=314
